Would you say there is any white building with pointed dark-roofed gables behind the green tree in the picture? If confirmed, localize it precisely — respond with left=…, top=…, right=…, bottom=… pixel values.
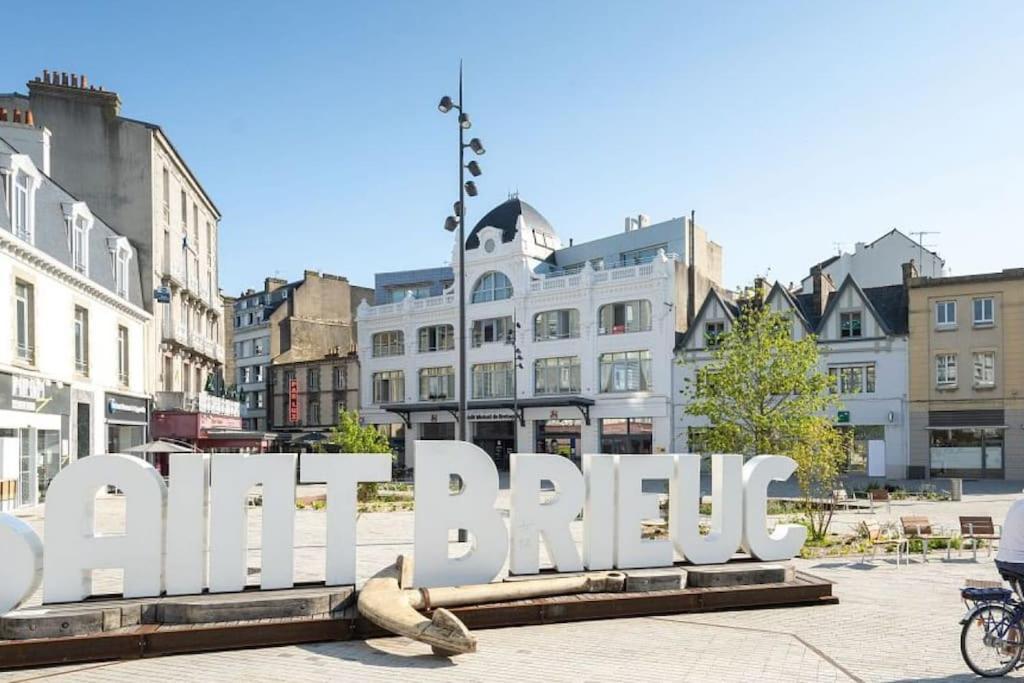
left=674, top=271, right=909, bottom=478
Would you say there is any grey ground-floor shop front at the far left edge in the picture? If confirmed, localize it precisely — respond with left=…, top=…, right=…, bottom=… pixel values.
left=0, top=373, right=71, bottom=510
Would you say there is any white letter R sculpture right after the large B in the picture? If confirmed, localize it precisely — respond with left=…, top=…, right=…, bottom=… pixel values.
left=509, top=453, right=584, bottom=574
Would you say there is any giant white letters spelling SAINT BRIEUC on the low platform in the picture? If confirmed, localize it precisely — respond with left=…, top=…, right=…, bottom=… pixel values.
left=0, top=441, right=807, bottom=613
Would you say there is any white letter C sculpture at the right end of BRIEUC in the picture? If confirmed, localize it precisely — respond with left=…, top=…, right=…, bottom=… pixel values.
left=743, top=456, right=807, bottom=561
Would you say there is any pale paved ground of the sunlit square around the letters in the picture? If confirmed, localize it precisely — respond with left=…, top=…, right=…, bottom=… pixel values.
left=0, top=483, right=1017, bottom=682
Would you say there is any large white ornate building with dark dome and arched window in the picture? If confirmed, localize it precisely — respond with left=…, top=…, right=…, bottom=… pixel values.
left=357, top=194, right=721, bottom=466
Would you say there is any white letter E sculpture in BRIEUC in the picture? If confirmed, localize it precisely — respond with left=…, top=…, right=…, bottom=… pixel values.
left=615, top=456, right=676, bottom=569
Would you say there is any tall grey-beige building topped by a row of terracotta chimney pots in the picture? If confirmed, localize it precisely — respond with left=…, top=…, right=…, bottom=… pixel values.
left=0, top=72, right=224, bottom=403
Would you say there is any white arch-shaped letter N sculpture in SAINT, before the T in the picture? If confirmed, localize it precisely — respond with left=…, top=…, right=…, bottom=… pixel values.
left=210, top=453, right=296, bottom=593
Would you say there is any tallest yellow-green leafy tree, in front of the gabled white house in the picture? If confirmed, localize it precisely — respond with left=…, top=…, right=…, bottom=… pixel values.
left=683, top=292, right=849, bottom=540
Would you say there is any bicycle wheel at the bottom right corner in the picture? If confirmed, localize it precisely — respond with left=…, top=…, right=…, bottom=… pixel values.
left=961, top=603, right=1024, bottom=678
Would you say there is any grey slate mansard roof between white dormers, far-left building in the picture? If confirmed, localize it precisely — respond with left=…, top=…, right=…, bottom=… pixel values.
left=0, top=137, right=143, bottom=308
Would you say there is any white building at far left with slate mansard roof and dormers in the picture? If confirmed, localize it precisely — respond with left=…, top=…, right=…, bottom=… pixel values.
left=0, top=112, right=153, bottom=510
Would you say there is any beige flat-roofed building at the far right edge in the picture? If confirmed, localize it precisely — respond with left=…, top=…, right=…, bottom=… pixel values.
left=909, top=268, right=1024, bottom=479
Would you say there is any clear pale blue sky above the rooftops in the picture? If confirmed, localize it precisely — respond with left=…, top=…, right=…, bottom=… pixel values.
left=0, top=0, right=1024, bottom=294
